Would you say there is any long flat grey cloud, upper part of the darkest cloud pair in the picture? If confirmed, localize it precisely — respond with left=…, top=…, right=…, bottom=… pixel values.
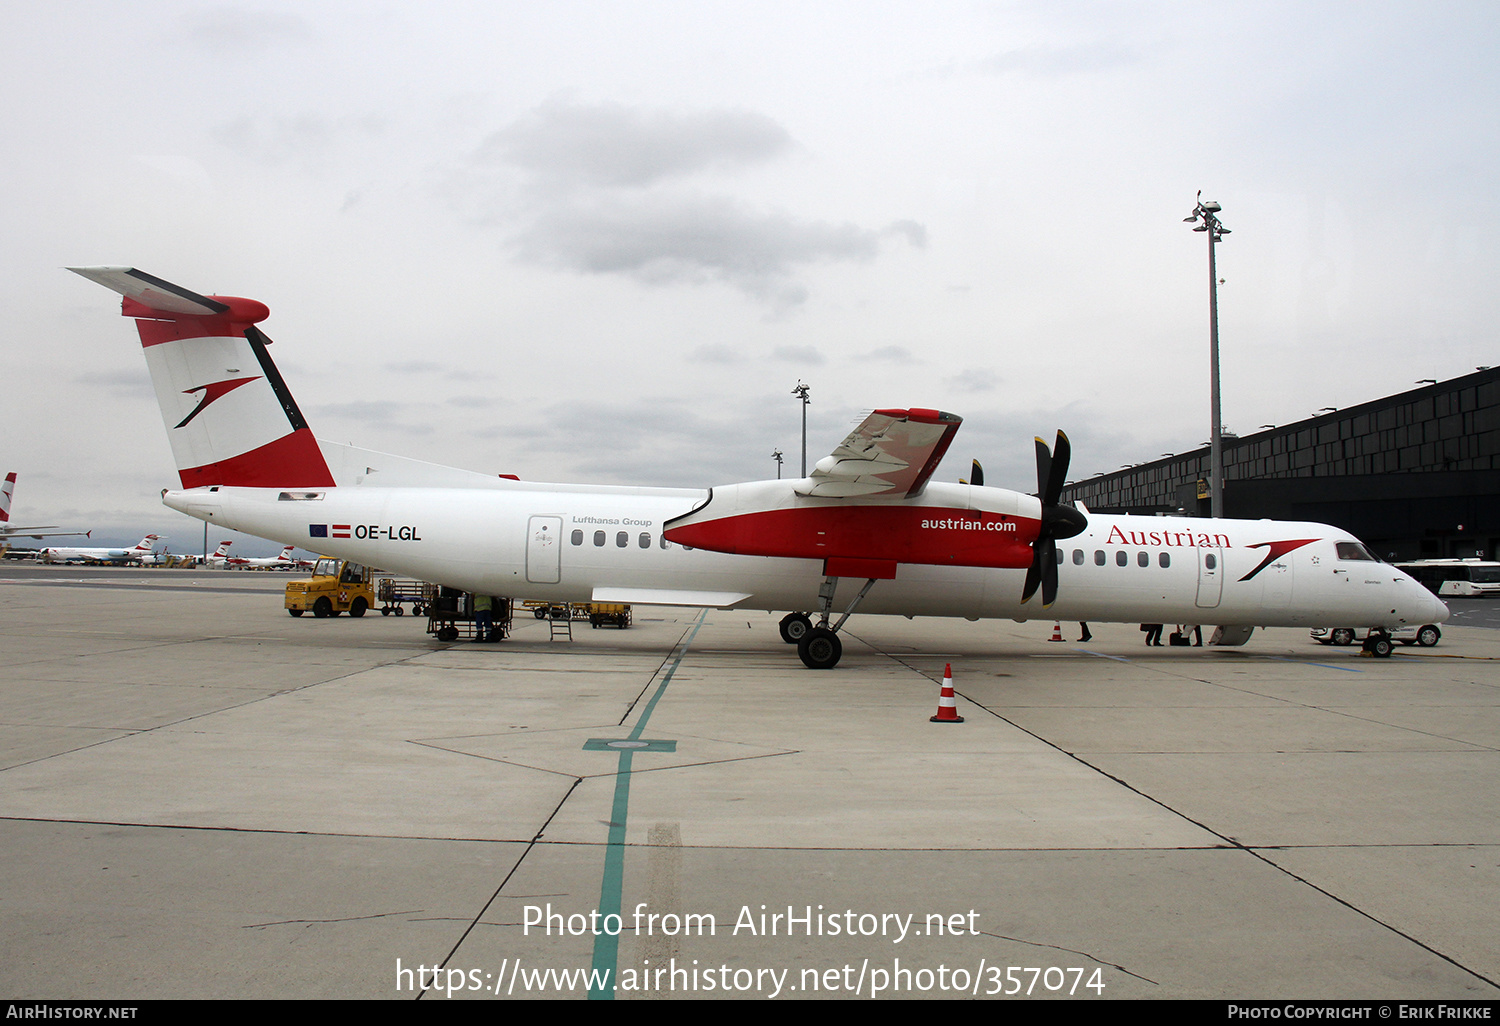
left=480, top=102, right=792, bottom=186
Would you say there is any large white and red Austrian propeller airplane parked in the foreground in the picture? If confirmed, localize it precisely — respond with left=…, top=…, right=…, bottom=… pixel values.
left=72, top=267, right=1448, bottom=669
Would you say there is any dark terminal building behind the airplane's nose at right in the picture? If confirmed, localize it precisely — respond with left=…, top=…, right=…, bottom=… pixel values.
left=1062, top=368, right=1500, bottom=560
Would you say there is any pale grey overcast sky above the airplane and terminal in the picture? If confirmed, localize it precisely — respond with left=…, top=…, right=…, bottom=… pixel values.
left=0, top=0, right=1500, bottom=551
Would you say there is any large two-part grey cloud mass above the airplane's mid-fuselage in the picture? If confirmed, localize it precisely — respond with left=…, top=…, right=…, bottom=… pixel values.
left=450, top=102, right=927, bottom=309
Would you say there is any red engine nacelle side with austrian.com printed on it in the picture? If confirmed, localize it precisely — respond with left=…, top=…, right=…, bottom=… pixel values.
left=666, top=506, right=1041, bottom=570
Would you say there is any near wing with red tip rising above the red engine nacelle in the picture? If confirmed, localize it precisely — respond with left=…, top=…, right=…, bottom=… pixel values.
left=797, top=410, right=963, bottom=498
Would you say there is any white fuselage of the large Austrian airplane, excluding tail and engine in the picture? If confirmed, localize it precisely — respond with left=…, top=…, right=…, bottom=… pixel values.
left=164, top=485, right=1448, bottom=627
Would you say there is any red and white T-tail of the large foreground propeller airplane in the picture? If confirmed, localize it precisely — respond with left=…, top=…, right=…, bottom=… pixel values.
left=69, top=267, right=335, bottom=488
